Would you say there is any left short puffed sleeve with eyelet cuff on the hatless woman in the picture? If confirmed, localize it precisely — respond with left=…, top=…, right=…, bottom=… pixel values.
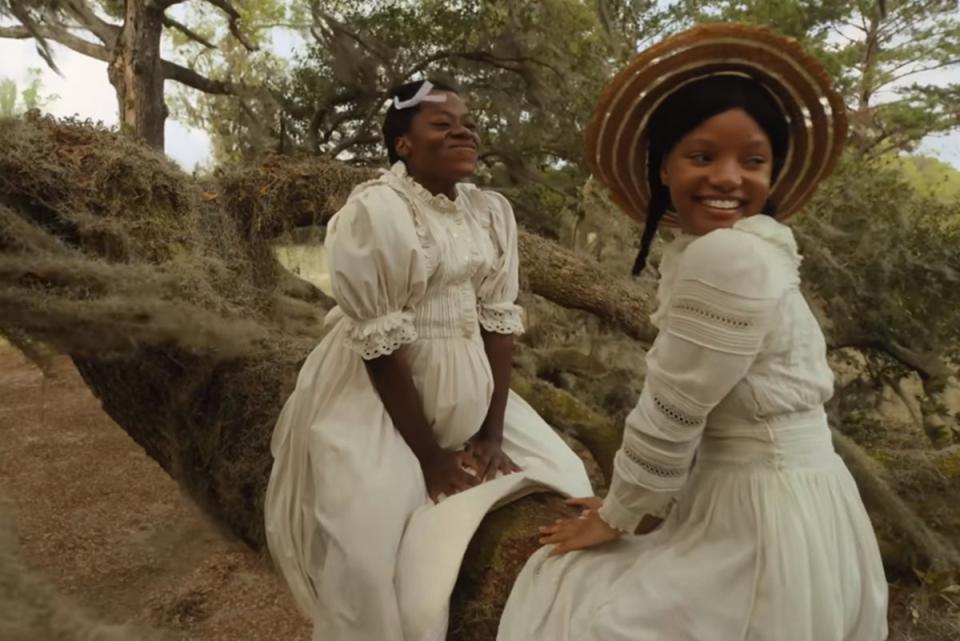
left=326, top=186, right=427, bottom=360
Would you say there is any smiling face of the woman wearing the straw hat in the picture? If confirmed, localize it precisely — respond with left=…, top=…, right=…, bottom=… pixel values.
left=660, top=109, right=773, bottom=236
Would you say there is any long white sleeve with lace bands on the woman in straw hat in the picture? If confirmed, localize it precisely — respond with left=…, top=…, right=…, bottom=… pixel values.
left=600, top=229, right=786, bottom=532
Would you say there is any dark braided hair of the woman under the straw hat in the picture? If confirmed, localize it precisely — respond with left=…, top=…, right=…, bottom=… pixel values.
left=633, top=75, right=790, bottom=275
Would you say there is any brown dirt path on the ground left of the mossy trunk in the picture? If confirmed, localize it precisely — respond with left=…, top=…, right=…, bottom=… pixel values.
left=0, top=346, right=310, bottom=641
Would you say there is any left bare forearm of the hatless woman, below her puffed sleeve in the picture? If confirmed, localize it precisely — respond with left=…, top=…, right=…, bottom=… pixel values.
left=366, top=352, right=441, bottom=464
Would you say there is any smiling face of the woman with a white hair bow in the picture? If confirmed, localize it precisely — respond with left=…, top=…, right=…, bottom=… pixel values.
left=396, top=91, right=479, bottom=191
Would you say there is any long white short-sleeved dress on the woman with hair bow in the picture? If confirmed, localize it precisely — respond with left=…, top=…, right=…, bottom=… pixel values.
left=264, top=163, right=591, bottom=641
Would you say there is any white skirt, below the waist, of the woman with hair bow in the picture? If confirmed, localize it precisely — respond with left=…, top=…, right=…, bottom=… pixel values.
left=264, top=323, right=592, bottom=641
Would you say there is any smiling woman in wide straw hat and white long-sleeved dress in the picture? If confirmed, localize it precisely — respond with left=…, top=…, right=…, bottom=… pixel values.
left=498, top=24, right=887, bottom=641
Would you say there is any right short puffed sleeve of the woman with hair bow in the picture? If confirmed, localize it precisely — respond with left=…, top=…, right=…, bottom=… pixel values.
left=478, top=191, right=523, bottom=334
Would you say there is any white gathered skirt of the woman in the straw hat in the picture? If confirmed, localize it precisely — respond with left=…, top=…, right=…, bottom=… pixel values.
left=497, top=416, right=887, bottom=641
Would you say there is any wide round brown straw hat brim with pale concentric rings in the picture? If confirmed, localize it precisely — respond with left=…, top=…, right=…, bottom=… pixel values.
left=586, top=23, right=847, bottom=225
